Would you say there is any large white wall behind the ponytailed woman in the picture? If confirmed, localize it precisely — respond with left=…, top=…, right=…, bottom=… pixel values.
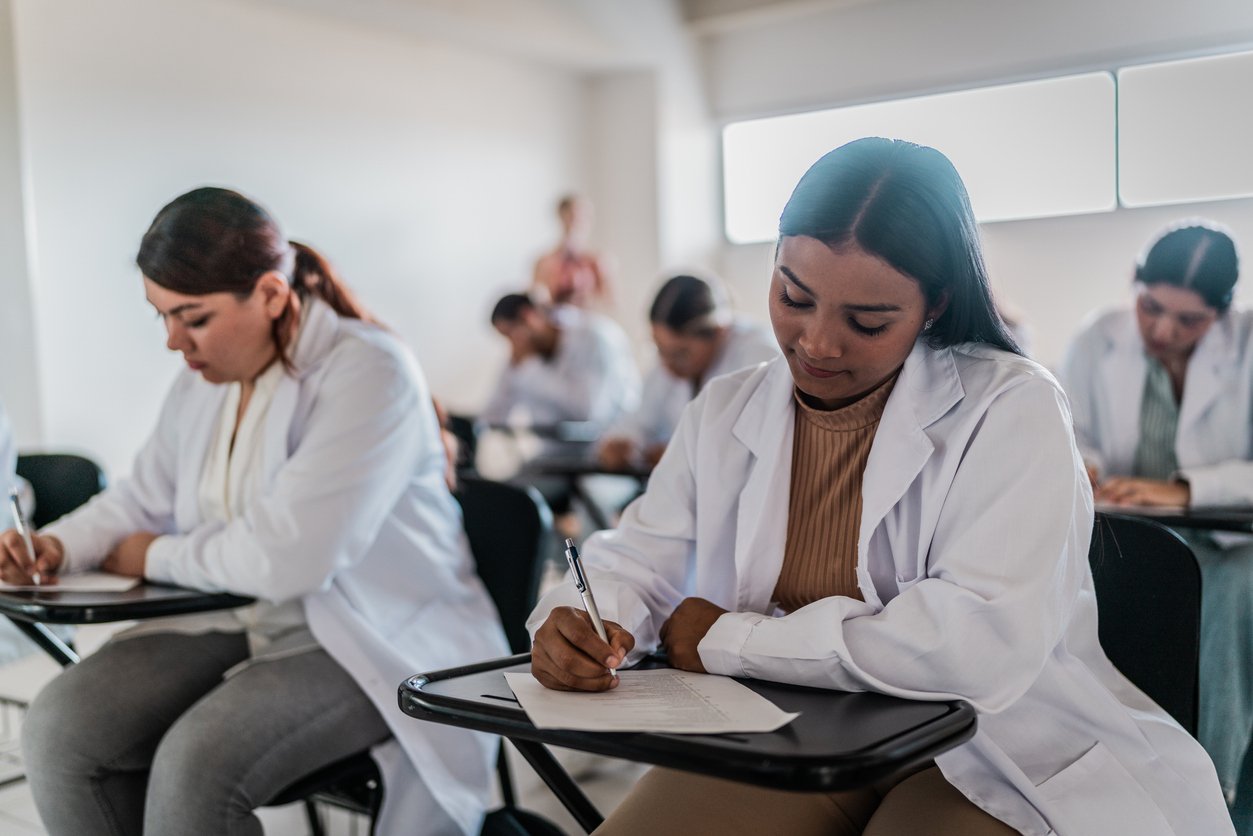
left=12, top=0, right=589, bottom=474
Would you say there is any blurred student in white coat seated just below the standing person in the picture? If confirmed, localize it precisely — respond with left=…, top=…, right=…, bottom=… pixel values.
left=479, top=293, right=639, bottom=429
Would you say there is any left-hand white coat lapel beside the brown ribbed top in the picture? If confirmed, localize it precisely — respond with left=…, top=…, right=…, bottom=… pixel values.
left=732, top=360, right=794, bottom=613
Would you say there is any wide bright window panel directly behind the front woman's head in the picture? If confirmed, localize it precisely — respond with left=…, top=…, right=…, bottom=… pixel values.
left=723, top=73, right=1116, bottom=243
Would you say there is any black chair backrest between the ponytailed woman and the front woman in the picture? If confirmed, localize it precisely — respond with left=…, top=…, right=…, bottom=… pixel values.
left=457, top=476, right=553, bottom=653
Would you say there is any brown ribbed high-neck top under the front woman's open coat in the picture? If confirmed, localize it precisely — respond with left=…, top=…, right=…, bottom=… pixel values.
left=774, top=375, right=896, bottom=613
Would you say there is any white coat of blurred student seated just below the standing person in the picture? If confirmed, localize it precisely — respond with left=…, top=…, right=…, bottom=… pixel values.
left=479, top=307, right=639, bottom=429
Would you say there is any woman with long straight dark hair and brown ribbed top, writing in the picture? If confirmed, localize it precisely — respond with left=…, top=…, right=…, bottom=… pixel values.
left=531, top=139, right=1230, bottom=836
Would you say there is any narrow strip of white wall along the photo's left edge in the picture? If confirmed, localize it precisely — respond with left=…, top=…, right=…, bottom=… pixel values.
left=0, top=0, right=40, bottom=446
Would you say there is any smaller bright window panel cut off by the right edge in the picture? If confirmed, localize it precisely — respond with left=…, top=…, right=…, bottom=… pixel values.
left=1118, top=53, right=1253, bottom=207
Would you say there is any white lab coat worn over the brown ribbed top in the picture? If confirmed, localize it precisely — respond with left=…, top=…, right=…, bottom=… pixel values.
left=531, top=342, right=1233, bottom=836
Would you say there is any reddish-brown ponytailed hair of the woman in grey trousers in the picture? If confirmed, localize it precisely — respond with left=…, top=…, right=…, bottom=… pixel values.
left=135, top=187, right=375, bottom=367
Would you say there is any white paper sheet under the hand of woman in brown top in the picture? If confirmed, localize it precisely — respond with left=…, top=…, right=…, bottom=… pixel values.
left=505, top=668, right=799, bottom=734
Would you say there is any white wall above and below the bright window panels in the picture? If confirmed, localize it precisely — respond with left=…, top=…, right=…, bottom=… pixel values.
left=703, top=0, right=1253, bottom=365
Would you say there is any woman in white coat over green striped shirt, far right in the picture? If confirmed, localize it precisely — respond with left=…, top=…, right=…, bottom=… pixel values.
left=1063, top=221, right=1253, bottom=812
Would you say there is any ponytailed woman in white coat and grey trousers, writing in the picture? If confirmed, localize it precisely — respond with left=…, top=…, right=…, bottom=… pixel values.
left=0, top=188, right=506, bottom=836
